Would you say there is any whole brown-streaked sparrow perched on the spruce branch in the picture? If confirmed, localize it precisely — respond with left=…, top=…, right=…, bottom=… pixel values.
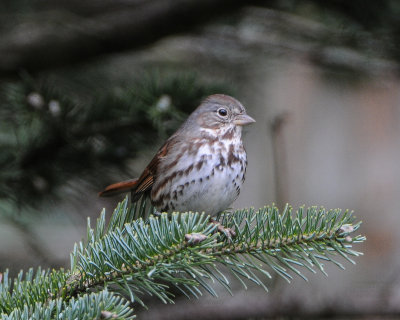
left=99, top=94, right=255, bottom=215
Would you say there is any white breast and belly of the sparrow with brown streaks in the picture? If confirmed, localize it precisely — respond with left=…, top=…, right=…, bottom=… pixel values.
left=151, top=136, right=247, bottom=215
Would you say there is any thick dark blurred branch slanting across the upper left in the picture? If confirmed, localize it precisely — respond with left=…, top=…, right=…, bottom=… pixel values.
left=0, top=0, right=262, bottom=74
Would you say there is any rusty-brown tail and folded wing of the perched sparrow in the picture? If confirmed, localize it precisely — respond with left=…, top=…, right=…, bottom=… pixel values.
left=99, top=140, right=170, bottom=202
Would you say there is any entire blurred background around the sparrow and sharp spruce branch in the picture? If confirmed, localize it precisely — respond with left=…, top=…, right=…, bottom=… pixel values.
left=0, top=0, right=400, bottom=319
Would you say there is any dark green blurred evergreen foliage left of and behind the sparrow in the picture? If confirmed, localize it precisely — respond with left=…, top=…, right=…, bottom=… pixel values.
left=0, top=71, right=229, bottom=206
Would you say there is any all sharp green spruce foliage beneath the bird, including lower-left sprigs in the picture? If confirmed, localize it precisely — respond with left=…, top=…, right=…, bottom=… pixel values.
left=0, top=198, right=365, bottom=320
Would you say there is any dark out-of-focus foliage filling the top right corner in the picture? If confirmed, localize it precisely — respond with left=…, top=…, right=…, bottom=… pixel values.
left=271, top=0, right=400, bottom=61
